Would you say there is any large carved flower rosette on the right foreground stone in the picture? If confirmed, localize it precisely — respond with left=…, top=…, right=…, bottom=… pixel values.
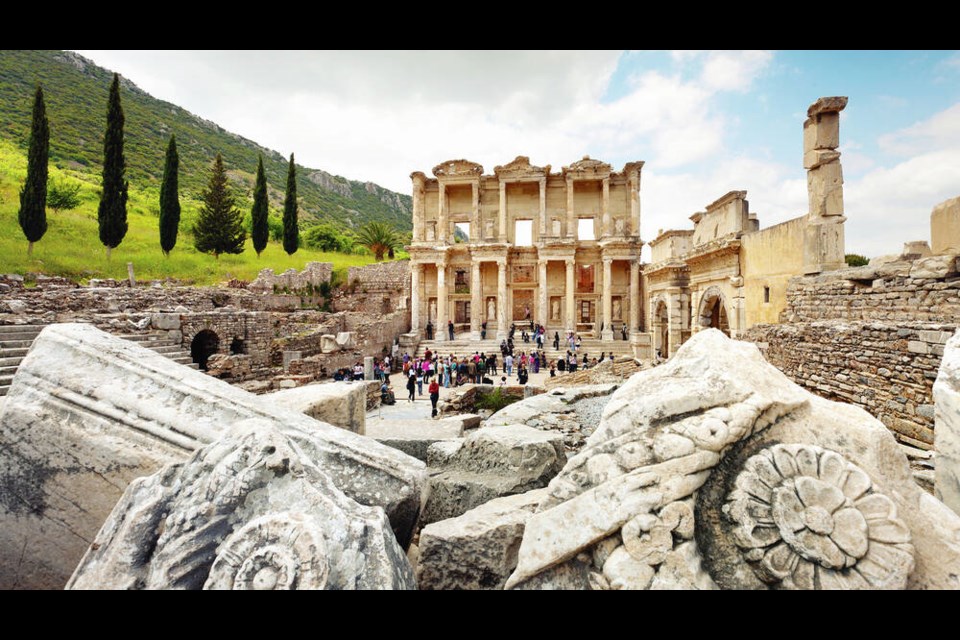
left=723, top=444, right=914, bottom=589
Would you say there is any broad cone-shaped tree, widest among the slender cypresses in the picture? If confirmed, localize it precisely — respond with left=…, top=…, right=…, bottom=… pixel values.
left=193, top=153, right=247, bottom=260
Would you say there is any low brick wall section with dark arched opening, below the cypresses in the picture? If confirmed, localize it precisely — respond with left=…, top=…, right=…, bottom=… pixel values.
left=180, top=311, right=273, bottom=366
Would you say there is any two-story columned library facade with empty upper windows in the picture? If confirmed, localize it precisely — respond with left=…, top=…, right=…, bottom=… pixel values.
left=407, top=156, right=643, bottom=340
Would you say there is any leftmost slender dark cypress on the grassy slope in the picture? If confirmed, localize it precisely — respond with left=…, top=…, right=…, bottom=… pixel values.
left=17, top=85, right=50, bottom=255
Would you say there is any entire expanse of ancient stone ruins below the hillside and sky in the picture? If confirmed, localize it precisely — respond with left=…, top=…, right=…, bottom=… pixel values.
left=0, top=97, right=960, bottom=590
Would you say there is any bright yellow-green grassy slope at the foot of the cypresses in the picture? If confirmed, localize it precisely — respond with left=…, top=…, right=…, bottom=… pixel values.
left=0, top=140, right=382, bottom=284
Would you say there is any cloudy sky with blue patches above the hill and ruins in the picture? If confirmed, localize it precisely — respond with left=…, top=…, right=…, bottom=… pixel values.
left=80, top=51, right=960, bottom=256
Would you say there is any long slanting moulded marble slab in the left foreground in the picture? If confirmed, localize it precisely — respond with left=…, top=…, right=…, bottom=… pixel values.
left=0, top=324, right=424, bottom=589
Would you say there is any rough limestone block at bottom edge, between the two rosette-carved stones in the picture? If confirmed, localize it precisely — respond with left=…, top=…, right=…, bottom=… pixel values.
left=416, top=489, right=546, bottom=590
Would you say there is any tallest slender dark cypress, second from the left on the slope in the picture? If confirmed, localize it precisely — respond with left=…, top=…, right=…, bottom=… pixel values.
left=97, top=73, right=127, bottom=260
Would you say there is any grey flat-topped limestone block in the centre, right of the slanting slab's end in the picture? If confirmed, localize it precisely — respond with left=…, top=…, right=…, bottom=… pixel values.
left=421, top=425, right=566, bottom=524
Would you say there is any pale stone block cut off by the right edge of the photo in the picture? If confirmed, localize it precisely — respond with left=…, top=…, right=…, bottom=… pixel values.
left=933, top=334, right=960, bottom=513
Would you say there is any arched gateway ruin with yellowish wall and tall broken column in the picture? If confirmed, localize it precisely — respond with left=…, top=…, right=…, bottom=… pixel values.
left=635, top=97, right=847, bottom=357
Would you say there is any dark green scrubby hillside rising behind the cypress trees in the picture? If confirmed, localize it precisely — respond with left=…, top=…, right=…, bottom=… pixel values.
left=0, top=51, right=411, bottom=230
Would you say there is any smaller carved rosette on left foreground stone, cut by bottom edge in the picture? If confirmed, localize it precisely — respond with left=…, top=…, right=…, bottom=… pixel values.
left=203, top=513, right=330, bottom=591
